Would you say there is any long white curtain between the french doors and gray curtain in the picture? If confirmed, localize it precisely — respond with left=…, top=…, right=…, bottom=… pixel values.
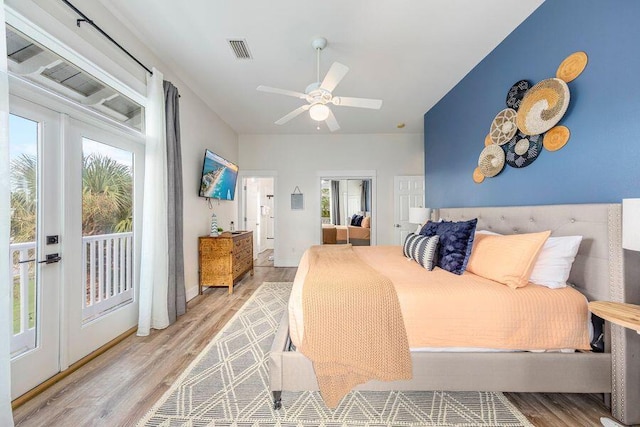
left=138, top=68, right=169, bottom=336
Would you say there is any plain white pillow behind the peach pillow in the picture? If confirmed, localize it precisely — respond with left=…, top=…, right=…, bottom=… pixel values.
left=476, top=230, right=582, bottom=289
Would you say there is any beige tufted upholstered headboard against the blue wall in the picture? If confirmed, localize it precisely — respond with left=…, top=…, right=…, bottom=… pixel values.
left=436, top=204, right=623, bottom=301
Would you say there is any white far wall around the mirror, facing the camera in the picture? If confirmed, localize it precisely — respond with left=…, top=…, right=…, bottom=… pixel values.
left=239, top=134, right=424, bottom=267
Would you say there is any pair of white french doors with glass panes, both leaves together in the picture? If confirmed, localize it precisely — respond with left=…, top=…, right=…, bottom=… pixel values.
left=9, top=96, right=144, bottom=398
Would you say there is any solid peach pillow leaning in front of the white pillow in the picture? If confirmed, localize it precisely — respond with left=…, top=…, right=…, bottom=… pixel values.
left=467, top=231, right=551, bottom=289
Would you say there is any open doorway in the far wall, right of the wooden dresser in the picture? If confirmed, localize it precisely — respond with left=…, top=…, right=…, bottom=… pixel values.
left=240, top=176, right=275, bottom=267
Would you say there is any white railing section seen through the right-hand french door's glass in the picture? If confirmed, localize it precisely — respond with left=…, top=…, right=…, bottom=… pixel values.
left=82, top=233, right=133, bottom=322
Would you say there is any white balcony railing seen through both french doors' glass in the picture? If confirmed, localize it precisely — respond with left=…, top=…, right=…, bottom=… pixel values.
left=9, top=233, right=134, bottom=356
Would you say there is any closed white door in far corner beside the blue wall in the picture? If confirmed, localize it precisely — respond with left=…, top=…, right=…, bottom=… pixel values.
left=393, top=176, right=424, bottom=245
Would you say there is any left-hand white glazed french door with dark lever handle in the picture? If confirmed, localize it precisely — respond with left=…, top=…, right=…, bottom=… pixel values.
left=9, top=96, right=63, bottom=399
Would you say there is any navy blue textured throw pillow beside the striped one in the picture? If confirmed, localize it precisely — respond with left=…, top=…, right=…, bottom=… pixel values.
left=420, top=218, right=478, bottom=274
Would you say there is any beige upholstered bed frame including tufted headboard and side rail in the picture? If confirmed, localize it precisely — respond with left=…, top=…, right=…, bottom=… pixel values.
left=269, top=204, right=640, bottom=424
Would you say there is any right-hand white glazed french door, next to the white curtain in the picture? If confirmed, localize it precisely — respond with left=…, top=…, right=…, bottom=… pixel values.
left=62, top=116, right=144, bottom=369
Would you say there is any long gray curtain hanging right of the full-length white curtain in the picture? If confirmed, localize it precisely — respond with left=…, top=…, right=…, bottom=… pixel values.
left=163, top=80, right=187, bottom=323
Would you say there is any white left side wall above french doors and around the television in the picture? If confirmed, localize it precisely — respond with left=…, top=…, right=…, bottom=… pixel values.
left=5, top=0, right=238, bottom=298
